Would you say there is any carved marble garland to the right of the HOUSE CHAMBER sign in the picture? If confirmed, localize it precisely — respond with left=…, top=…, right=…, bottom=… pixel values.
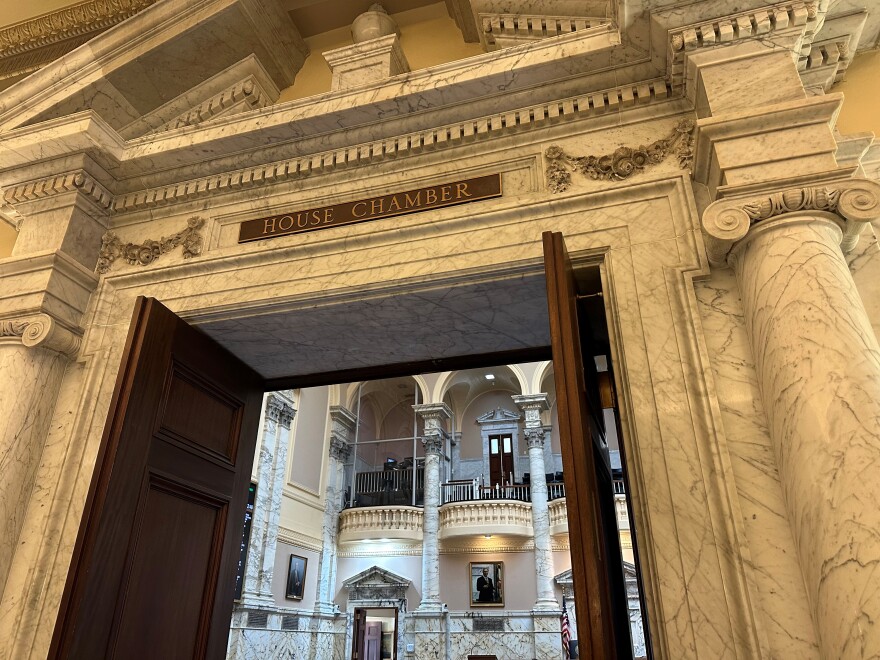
left=544, top=119, right=696, bottom=193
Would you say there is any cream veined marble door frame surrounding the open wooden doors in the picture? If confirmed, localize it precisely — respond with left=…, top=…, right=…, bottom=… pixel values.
left=10, top=174, right=761, bottom=658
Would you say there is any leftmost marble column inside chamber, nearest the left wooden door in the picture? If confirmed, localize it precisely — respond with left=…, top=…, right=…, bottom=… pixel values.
left=241, top=392, right=296, bottom=607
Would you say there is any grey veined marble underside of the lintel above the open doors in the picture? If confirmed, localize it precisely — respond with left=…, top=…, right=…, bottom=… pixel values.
left=193, top=273, right=550, bottom=382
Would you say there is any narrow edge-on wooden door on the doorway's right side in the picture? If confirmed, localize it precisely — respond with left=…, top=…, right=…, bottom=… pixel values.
left=542, top=232, right=632, bottom=660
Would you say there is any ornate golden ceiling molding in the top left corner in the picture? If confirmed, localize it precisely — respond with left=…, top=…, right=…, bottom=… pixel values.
left=0, top=0, right=156, bottom=79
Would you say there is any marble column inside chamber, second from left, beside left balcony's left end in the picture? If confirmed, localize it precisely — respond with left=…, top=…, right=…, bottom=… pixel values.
left=315, top=406, right=357, bottom=615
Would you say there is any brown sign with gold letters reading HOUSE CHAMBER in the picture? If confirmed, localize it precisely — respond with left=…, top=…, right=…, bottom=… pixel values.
left=238, top=174, right=501, bottom=243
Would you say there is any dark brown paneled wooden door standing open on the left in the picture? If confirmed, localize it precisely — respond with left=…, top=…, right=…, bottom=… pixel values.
left=49, top=298, right=264, bottom=660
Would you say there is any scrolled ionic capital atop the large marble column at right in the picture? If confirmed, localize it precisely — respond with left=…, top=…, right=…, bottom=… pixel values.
left=703, top=179, right=880, bottom=266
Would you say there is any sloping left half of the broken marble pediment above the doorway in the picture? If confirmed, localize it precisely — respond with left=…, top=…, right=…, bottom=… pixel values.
left=0, top=0, right=308, bottom=137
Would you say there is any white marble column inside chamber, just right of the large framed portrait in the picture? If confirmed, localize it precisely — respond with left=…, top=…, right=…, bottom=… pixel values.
left=513, top=394, right=559, bottom=611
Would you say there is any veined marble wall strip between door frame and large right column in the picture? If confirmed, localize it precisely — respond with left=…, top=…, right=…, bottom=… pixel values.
left=694, top=268, right=819, bottom=660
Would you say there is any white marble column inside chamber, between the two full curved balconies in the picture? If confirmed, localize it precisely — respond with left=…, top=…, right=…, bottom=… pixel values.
left=413, top=403, right=452, bottom=613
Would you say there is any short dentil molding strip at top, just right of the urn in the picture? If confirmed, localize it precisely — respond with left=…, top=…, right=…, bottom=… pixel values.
left=479, top=13, right=611, bottom=51
